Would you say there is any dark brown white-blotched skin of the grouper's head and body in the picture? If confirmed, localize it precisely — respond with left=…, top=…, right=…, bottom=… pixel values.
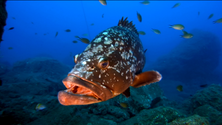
left=74, top=17, right=145, bottom=93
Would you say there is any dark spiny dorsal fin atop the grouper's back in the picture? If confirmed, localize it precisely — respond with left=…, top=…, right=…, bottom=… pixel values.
left=118, top=17, right=139, bottom=35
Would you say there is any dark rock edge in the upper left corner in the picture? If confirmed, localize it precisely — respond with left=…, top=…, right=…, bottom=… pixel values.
left=0, top=0, right=8, bottom=43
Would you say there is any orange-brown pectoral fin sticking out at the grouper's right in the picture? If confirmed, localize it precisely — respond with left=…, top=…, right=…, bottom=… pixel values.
left=131, top=71, right=162, bottom=88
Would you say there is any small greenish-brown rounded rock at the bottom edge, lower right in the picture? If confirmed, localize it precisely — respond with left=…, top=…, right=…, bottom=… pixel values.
left=169, top=115, right=210, bottom=125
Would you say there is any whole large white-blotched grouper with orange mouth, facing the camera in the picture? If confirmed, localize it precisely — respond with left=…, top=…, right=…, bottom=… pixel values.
left=58, top=18, right=162, bottom=105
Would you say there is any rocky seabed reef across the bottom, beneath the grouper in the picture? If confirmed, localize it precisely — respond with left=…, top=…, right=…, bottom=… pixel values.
left=0, top=57, right=222, bottom=125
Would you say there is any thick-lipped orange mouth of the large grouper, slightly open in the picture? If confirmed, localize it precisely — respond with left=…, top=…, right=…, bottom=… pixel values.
left=58, top=75, right=111, bottom=105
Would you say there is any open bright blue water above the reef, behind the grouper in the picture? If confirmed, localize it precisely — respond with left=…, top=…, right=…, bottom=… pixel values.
left=0, top=1, right=222, bottom=69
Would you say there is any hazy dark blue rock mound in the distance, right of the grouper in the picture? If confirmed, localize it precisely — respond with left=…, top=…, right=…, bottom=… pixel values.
left=146, top=30, right=221, bottom=83
